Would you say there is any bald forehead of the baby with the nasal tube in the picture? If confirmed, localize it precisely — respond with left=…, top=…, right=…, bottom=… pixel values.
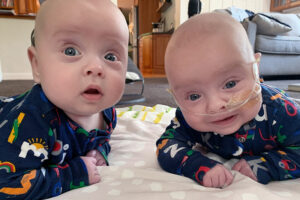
left=166, top=14, right=253, bottom=62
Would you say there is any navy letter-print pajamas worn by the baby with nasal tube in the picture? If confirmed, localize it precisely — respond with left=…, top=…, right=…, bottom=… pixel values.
left=156, top=84, right=300, bottom=184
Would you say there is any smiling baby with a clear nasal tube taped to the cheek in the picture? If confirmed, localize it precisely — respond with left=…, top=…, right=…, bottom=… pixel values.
left=157, top=13, right=300, bottom=187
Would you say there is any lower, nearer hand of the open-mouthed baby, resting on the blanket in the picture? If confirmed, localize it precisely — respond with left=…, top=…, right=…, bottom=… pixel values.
left=80, top=156, right=101, bottom=185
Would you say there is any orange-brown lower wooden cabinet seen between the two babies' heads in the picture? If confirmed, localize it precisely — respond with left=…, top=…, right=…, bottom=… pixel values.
left=139, top=33, right=171, bottom=76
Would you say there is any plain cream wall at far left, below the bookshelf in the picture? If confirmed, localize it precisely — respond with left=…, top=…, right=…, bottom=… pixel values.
left=0, top=18, right=34, bottom=80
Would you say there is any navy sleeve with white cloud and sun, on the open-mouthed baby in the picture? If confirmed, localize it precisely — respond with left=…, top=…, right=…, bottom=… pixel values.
left=0, top=111, right=88, bottom=199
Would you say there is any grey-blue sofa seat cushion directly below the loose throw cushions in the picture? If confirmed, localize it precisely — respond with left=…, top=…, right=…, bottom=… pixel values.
left=255, top=35, right=300, bottom=55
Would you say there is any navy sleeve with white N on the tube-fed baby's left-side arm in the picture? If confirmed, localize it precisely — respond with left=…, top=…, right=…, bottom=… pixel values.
left=156, top=110, right=218, bottom=184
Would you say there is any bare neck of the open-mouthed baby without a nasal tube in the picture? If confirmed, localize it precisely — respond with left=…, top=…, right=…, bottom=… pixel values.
left=67, top=112, right=104, bottom=131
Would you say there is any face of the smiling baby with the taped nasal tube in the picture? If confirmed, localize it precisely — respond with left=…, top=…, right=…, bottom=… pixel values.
left=166, top=32, right=261, bottom=135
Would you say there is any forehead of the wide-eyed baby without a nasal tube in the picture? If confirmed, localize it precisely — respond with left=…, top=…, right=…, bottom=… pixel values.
left=35, top=0, right=128, bottom=40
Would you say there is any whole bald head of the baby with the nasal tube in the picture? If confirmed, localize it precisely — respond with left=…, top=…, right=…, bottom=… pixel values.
left=165, top=13, right=261, bottom=134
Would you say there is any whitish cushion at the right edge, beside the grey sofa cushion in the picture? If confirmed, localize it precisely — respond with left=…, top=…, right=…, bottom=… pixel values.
left=266, top=13, right=300, bottom=36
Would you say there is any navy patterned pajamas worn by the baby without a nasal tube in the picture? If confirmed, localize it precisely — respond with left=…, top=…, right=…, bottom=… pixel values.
left=0, top=85, right=117, bottom=200
